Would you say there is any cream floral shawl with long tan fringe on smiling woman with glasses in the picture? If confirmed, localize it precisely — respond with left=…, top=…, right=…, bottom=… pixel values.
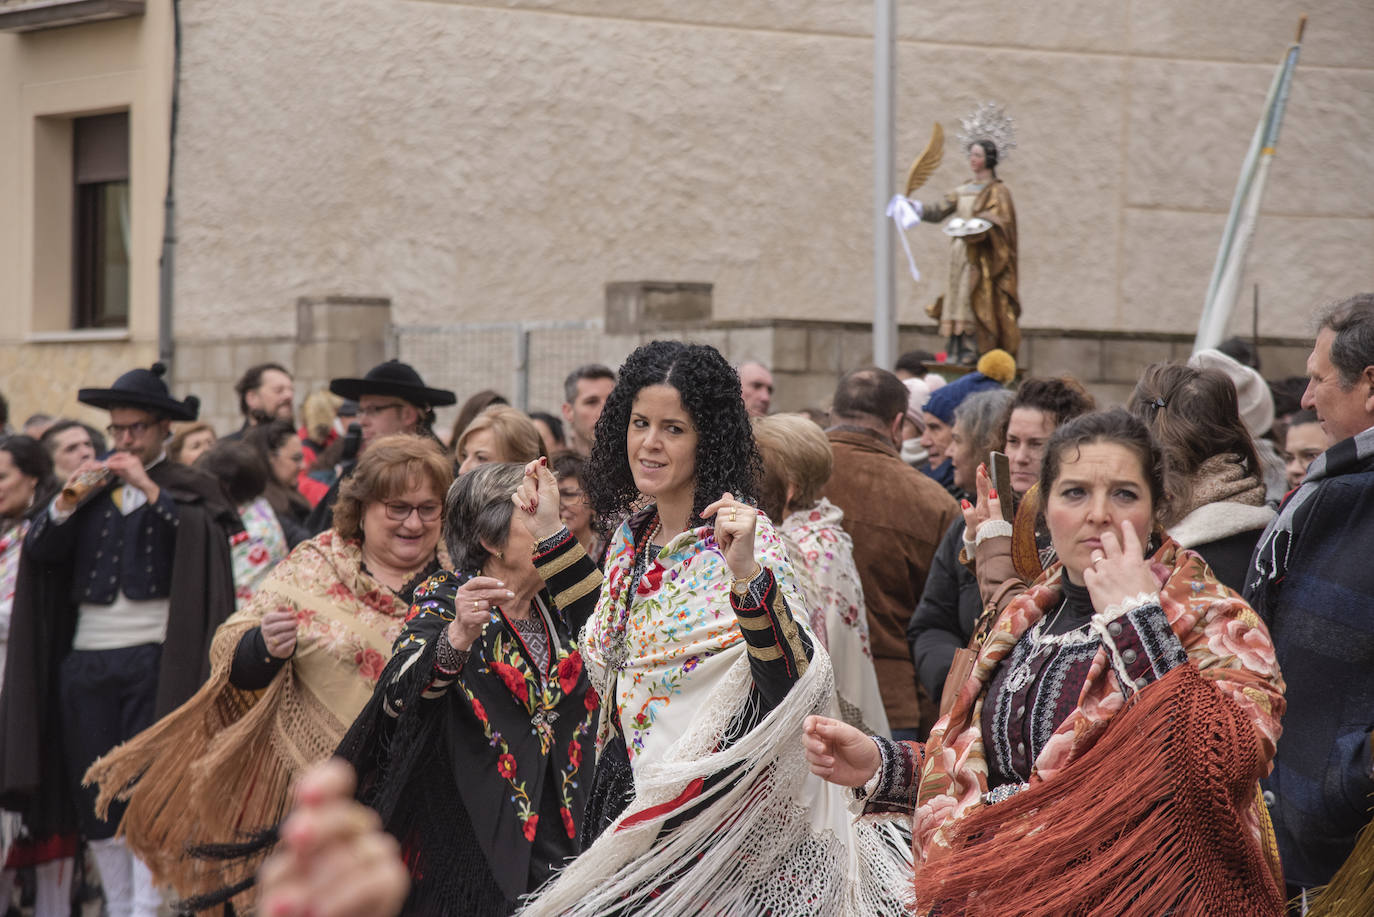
left=85, top=532, right=409, bottom=896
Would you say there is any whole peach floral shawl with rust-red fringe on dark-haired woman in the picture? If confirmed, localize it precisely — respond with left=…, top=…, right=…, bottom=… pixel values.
left=914, top=539, right=1283, bottom=917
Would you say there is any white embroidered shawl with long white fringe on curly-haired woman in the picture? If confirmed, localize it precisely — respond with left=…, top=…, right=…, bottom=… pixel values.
left=521, top=517, right=911, bottom=917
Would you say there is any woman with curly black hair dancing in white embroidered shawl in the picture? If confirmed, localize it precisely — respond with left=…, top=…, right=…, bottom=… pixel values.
left=522, top=341, right=901, bottom=917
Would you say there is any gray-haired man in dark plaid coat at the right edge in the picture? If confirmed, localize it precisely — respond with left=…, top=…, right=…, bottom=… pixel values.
left=1245, top=293, right=1374, bottom=913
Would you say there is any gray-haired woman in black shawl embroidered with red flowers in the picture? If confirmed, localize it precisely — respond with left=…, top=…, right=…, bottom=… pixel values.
left=339, top=459, right=602, bottom=914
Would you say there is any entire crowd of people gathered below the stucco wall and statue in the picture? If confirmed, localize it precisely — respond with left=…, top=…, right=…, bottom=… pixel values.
left=0, top=294, right=1374, bottom=917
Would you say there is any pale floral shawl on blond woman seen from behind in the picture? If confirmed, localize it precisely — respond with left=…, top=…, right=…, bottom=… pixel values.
left=778, top=498, right=890, bottom=736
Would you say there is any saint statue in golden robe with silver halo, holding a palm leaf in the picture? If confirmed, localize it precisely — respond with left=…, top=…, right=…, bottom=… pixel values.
left=905, top=102, right=1021, bottom=364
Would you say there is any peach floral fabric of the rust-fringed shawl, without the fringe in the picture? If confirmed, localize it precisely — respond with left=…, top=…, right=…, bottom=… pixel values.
left=912, top=539, right=1283, bottom=861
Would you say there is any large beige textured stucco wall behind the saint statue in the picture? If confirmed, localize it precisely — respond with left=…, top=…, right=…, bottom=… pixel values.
left=171, top=0, right=1374, bottom=351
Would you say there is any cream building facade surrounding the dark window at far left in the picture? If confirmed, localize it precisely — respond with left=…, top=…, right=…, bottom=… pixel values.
left=0, top=0, right=172, bottom=423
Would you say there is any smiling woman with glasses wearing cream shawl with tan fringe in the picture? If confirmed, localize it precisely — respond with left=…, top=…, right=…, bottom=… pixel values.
left=87, top=434, right=452, bottom=903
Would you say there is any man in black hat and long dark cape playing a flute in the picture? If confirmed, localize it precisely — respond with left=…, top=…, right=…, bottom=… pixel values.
left=0, top=364, right=238, bottom=917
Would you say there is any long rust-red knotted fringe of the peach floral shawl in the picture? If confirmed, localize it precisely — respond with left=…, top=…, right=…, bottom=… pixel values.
left=915, top=665, right=1280, bottom=917
